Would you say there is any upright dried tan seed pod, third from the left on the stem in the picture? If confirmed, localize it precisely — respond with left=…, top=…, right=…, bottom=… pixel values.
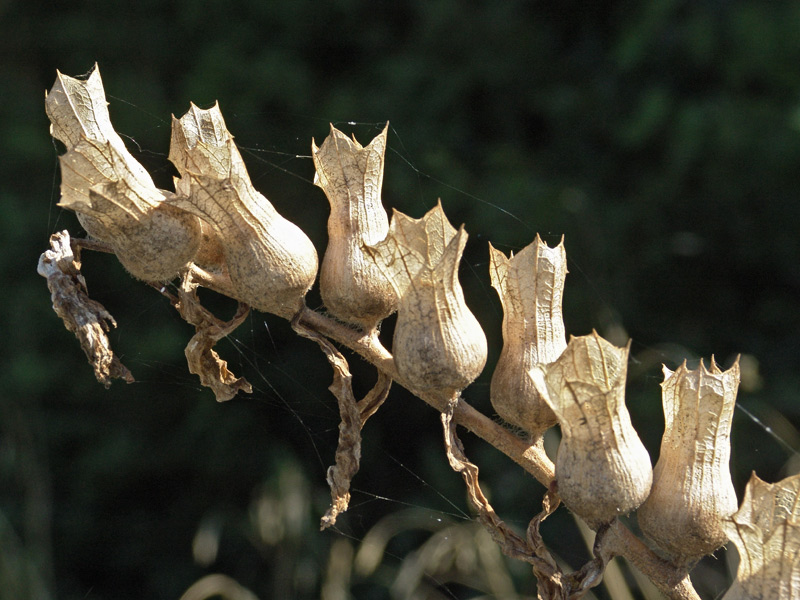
left=311, top=124, right=397, bottom=330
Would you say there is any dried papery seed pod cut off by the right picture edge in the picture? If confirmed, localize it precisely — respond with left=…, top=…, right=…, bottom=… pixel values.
left=723, top=473, right=800, bottom=600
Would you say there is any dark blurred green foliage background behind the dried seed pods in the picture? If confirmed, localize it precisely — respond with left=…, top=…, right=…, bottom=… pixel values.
left=0, top=0, right=800, bottom=599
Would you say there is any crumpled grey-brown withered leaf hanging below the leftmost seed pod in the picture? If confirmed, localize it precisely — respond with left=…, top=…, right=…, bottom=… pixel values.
left=37, top=231, right=134, bottom=387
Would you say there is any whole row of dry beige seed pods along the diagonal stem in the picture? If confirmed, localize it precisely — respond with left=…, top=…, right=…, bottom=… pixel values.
left=46, top=68, right=784, bottom=600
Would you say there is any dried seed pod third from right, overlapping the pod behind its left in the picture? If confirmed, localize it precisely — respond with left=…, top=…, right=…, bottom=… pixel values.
left=531, top=332, right=653, bottom=529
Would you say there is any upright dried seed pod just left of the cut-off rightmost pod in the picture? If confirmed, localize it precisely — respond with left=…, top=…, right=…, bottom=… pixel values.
left=636, top=358, right=739, bottom=564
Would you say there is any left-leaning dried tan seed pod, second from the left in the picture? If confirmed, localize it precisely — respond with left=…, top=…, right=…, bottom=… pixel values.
left=169, top=105, right=317, bottom=318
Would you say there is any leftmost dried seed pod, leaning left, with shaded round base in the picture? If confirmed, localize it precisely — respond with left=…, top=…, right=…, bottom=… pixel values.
left=45, top=66, right=201, bottom=282
